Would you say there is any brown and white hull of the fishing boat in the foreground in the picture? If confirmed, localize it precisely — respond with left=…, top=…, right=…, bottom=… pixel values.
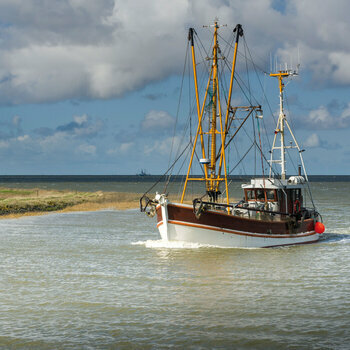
left=157, top=203, right=320, bottom=248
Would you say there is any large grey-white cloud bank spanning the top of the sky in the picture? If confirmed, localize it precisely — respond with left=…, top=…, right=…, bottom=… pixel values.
left=0, top=0, right=350, bottom=104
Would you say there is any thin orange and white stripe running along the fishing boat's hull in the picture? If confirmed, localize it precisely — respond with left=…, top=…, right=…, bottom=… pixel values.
left=165, top=220, right=316, bottom=238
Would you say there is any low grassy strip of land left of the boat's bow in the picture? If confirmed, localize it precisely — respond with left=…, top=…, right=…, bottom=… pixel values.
left=0, top=188, right=140, bottom=218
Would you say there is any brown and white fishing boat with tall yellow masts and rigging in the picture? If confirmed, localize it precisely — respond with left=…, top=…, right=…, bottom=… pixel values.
left=140, top=20, right=325, bottom=248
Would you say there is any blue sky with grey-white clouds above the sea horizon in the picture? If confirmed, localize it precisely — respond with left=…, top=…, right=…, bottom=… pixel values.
left=0, top=0, right=350, bottom=175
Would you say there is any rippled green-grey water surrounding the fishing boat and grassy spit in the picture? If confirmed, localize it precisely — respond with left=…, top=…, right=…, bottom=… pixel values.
left=0, top=182, right=350, bottom=349
